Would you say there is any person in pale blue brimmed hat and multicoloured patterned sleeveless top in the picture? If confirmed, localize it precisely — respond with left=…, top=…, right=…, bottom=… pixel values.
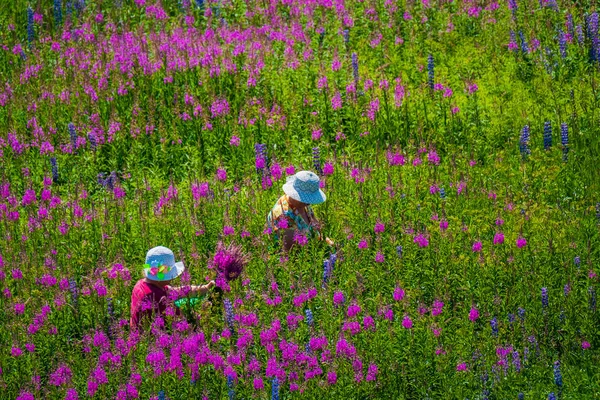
left=267, top=171, right=333, bottom=251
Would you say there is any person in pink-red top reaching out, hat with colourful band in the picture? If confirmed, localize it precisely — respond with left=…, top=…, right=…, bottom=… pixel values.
left=129, top=246, right=215, bottom=330
